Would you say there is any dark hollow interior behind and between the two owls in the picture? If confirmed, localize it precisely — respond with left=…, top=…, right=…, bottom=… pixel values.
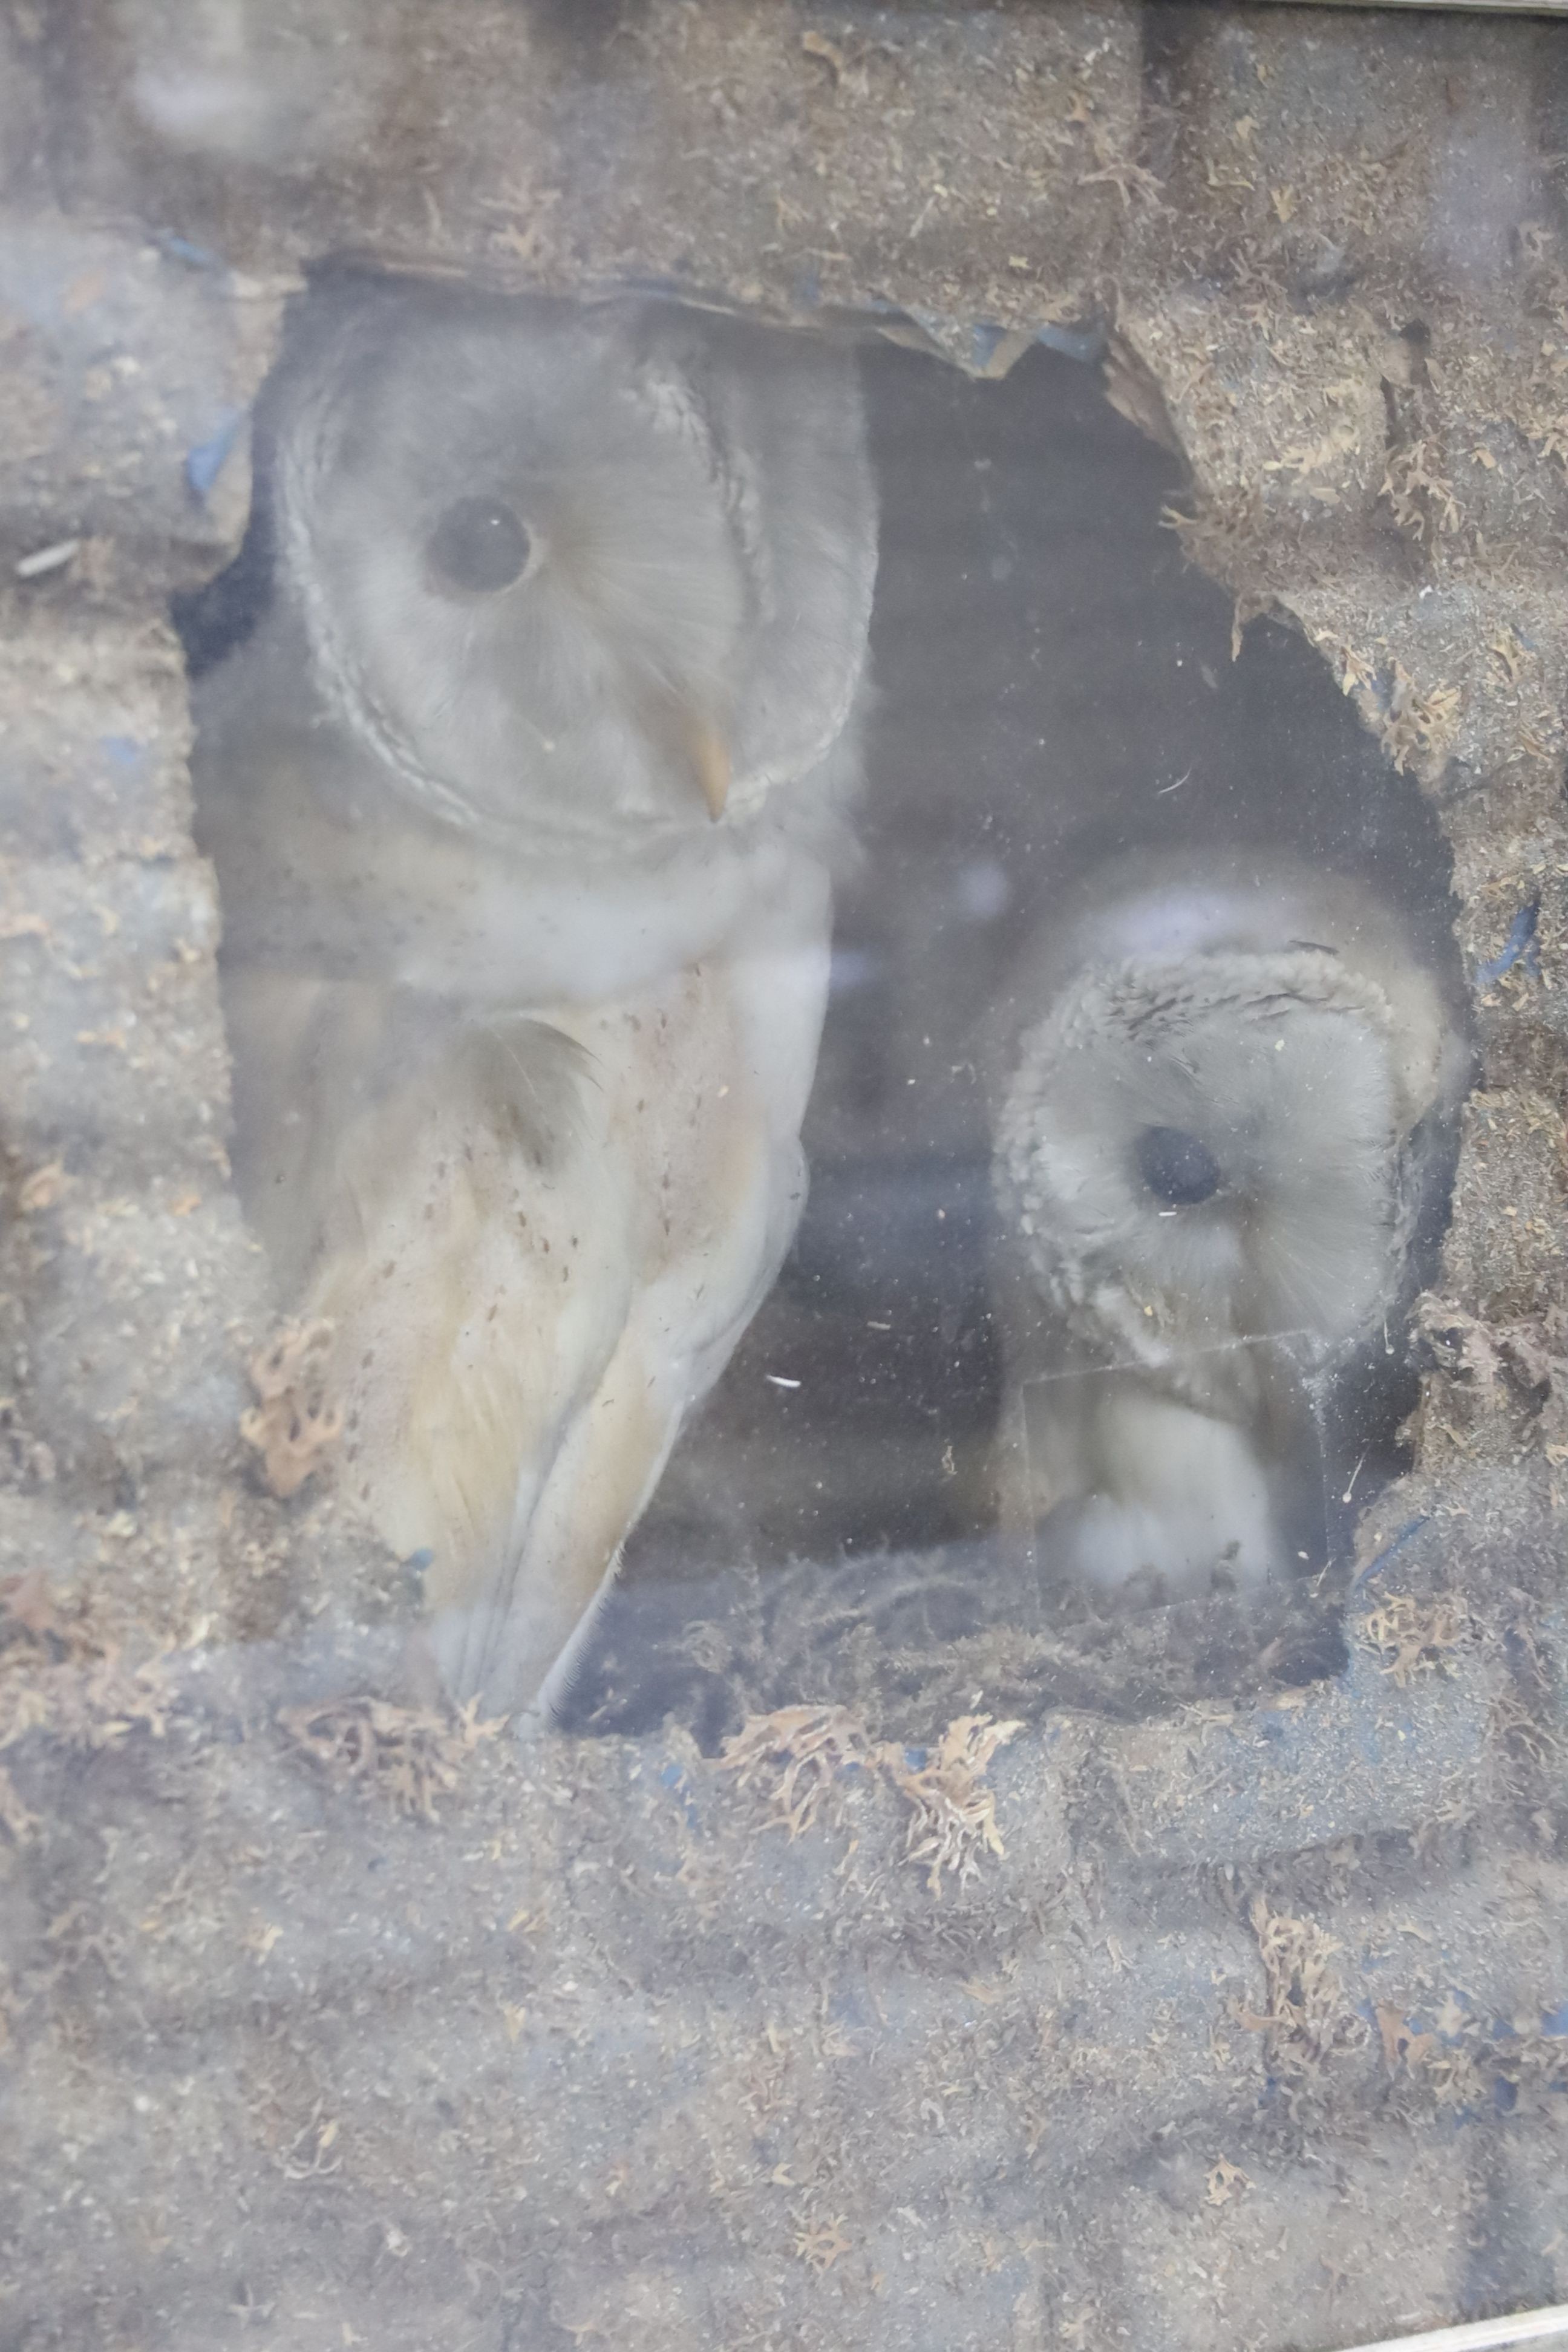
left=569, top=327, right=1453, bottom=1729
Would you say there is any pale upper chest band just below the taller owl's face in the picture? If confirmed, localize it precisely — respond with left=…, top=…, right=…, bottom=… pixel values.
left=197, top=628, right=854, bottom=1009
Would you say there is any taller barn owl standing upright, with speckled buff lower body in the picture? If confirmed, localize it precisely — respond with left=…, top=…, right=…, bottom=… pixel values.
left=197, top=283, right=877, bottom=1719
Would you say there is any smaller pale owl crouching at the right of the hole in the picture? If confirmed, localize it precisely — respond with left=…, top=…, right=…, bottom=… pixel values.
left=995, top=854, right=1465, bottom=1597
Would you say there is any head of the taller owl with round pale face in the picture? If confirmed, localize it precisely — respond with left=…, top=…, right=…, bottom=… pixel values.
left=288, top=287, right=875, bottom=861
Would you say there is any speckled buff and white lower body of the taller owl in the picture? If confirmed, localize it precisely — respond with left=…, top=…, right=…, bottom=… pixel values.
left=291, top=936, right=820, bottom=1710
